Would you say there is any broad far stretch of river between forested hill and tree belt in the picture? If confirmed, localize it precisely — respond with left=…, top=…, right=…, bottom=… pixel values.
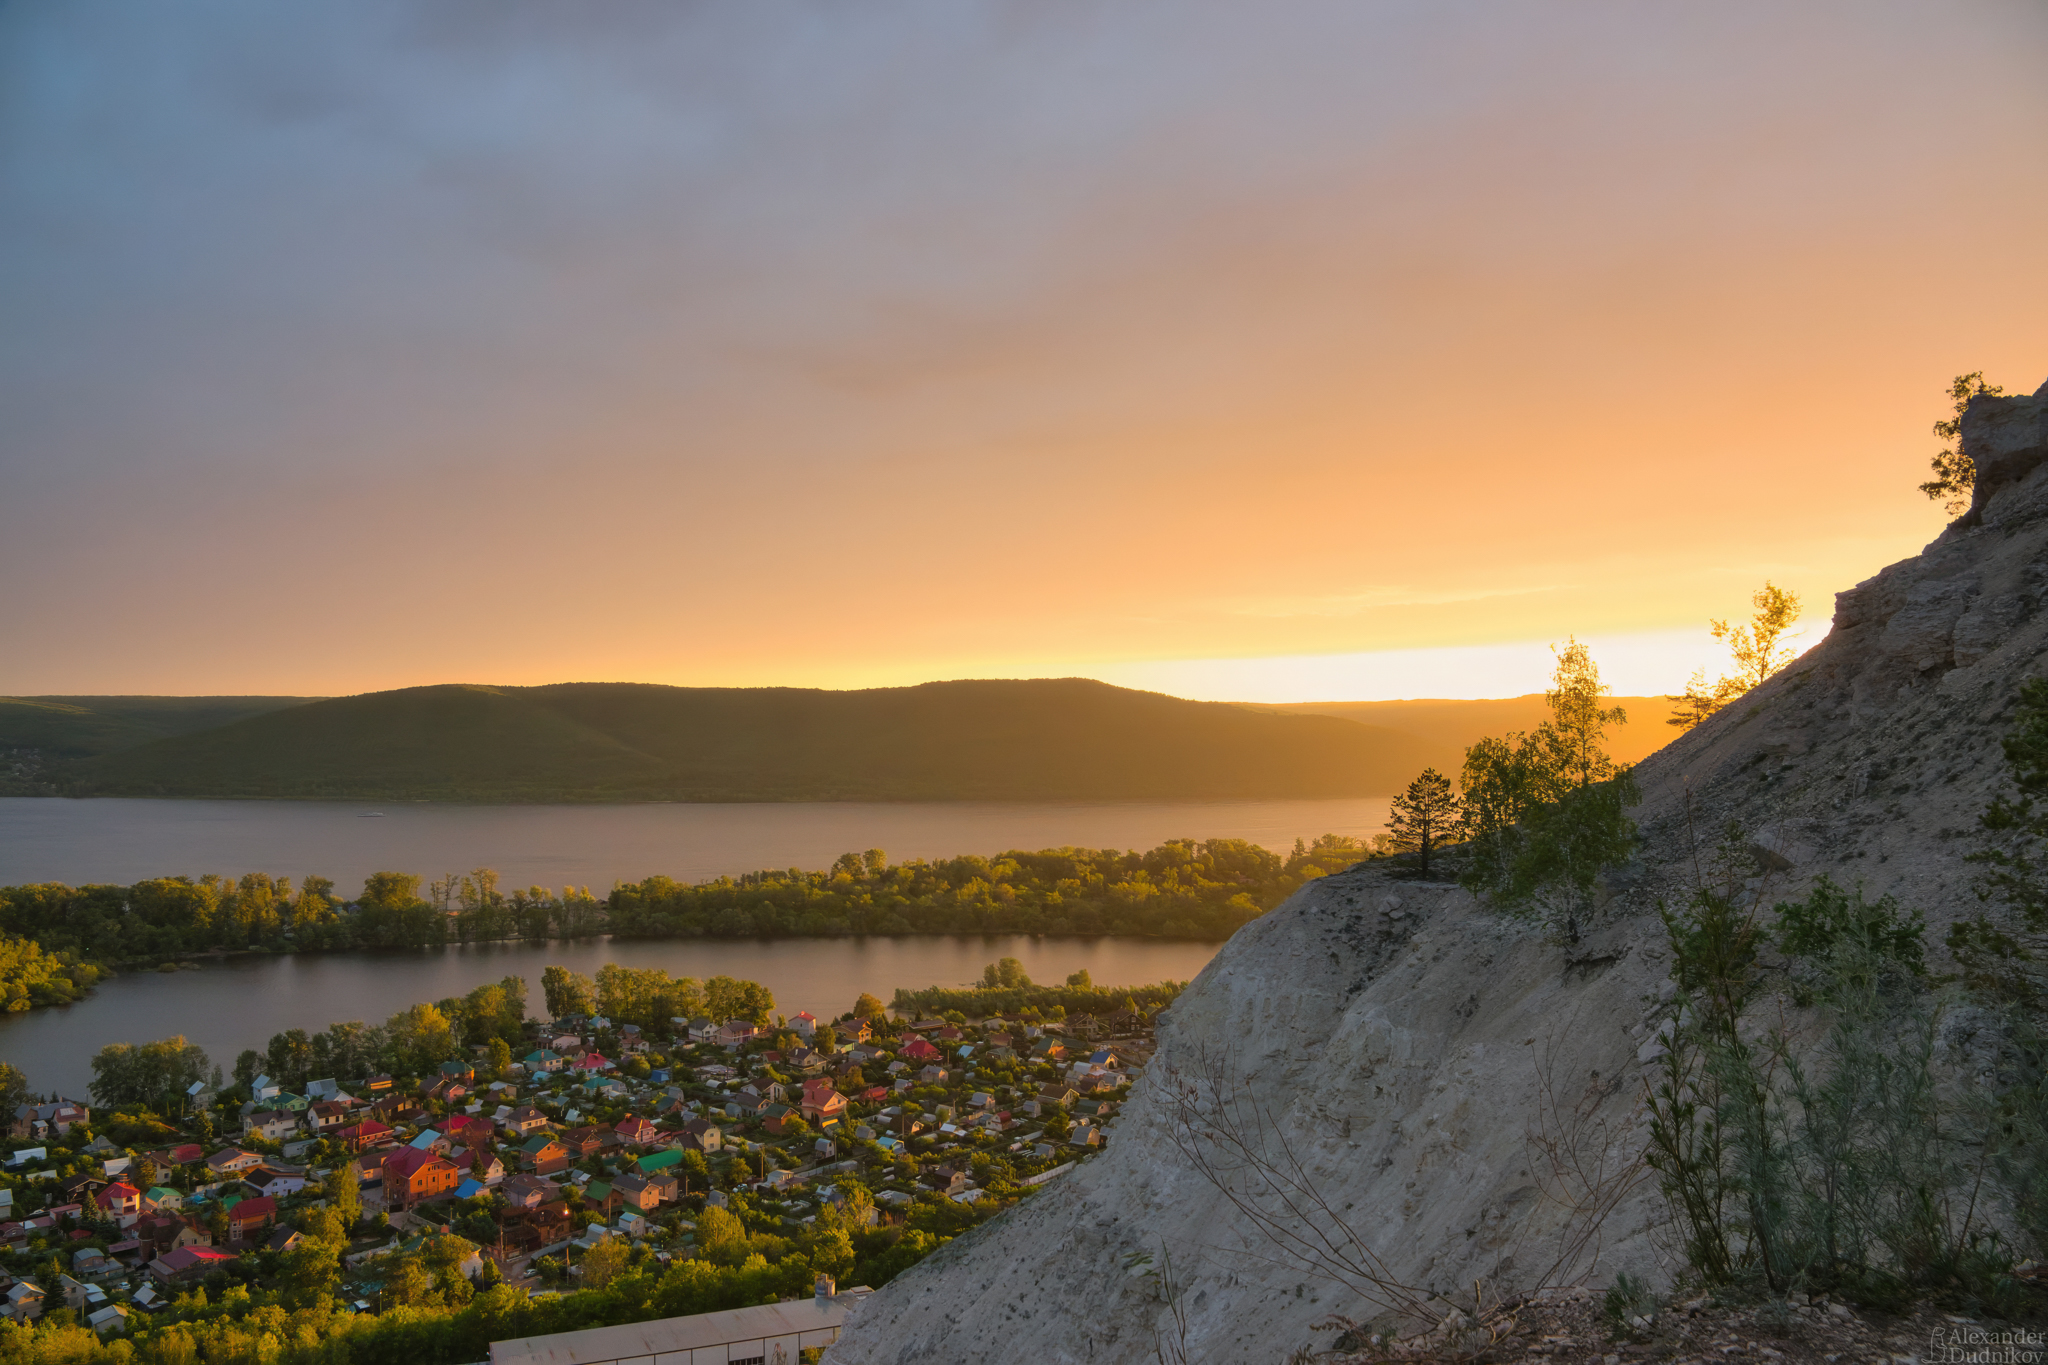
left=0, top=796, right=1389, bottom=896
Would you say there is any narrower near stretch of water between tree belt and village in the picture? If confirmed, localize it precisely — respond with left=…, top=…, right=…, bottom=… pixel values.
left=0, top=935, right=1219, bottom=1097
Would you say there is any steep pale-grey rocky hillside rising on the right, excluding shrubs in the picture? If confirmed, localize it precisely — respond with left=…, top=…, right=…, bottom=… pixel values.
left=829, top=374, right=2048, bottom=1365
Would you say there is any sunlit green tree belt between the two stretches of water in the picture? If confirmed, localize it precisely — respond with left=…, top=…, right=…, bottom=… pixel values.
left=0, top=835, right=1372, bottom=982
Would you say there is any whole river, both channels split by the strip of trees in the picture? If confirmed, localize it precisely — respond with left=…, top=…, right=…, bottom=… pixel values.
left=0, top=798, right=1386, bottom=1097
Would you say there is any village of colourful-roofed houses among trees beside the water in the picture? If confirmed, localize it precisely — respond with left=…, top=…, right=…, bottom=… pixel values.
left=0, top=994, right=1153, bottom=1338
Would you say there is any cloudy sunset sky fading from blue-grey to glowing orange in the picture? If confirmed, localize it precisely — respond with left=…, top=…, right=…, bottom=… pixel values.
left=0, top=0, right=2048, bottom=700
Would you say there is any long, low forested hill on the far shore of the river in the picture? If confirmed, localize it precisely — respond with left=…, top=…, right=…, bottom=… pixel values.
left=53, top=677, right=1442, bottom=800
